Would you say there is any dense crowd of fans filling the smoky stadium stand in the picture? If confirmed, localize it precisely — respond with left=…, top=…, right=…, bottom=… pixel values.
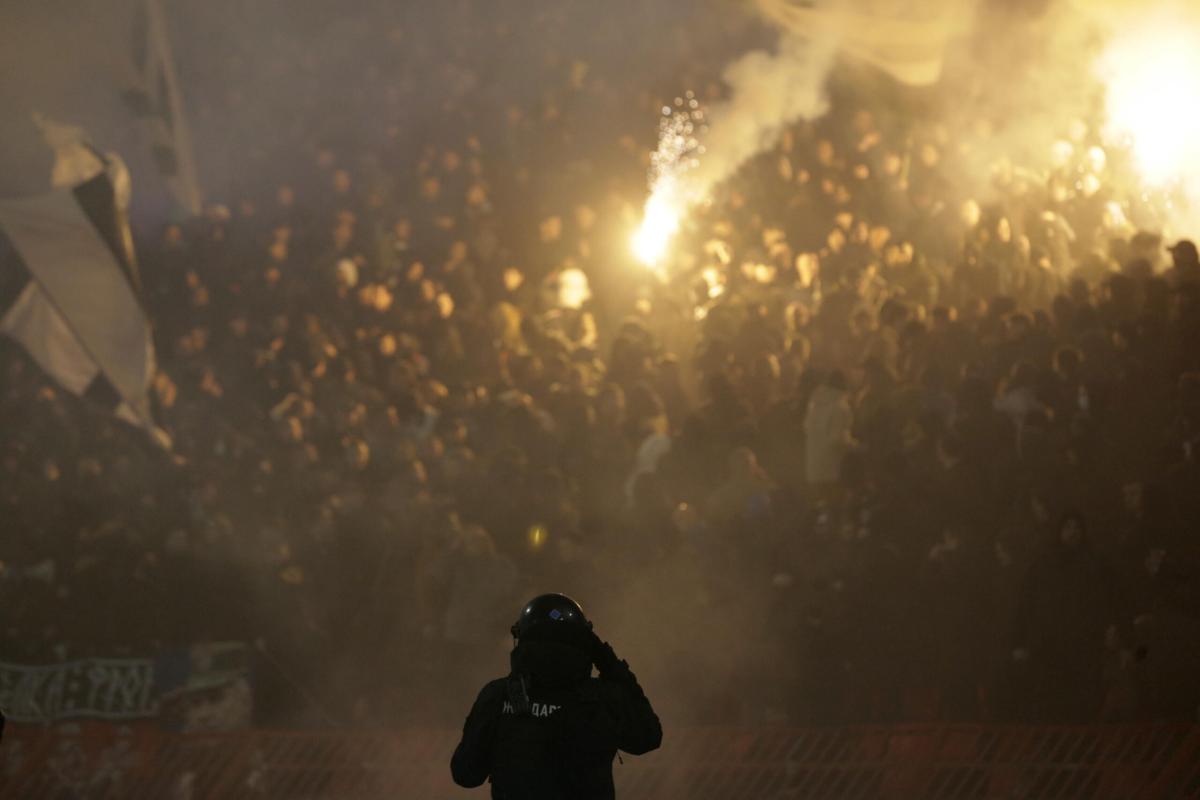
left=0, top=4, right=1200, bottom=723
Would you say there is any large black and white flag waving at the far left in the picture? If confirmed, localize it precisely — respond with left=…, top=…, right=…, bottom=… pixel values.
left=0, top=157, right=167, bottom=445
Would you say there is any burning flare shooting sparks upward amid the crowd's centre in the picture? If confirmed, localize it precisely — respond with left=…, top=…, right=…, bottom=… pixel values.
left=632, top=91, right=706, bottom=270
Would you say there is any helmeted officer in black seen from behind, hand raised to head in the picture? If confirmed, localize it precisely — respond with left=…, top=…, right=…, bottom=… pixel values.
left=450, top=595, right=662, bottom=800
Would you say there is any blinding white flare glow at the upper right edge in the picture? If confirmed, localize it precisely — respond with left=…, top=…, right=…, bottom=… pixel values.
left=1100, top=17, right=1200, bottom=187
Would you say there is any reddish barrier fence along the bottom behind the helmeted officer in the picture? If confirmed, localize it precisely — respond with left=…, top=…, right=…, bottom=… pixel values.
left=0, top=722, right=1200, bottom=800
